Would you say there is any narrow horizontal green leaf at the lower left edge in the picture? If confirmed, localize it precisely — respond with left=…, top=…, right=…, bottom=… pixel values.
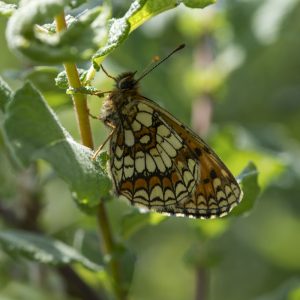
left=0, top=230, right=102, bottom=271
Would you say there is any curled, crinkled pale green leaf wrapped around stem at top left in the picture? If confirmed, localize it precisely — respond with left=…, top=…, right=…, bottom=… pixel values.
left=6, top=0, right=109, bottom=63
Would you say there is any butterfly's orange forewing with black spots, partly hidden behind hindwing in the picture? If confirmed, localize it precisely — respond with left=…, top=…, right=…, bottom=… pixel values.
left=147, top=99, right=243, bottom=218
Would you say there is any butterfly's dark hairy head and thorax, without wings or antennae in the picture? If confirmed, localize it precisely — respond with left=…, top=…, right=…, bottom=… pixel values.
left=100, top=72, right=138, bottom=127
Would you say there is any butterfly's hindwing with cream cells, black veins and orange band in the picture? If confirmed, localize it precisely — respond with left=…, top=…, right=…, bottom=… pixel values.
left=110, top=102, right=199, bottom=211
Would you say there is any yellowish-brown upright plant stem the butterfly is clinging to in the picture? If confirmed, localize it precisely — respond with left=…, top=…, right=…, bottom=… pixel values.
left=55, top=13, right=126, bottom=300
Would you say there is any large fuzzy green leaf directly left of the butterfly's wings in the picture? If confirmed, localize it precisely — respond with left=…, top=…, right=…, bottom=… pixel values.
left=3, top=83, right=111, bottom=209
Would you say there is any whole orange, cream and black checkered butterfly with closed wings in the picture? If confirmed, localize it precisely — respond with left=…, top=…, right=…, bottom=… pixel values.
left=94, top=45, right=243, bottom=219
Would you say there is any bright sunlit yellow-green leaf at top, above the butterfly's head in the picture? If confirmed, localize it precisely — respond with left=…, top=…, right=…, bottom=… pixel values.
left=93, top=0, right=215, bottom=65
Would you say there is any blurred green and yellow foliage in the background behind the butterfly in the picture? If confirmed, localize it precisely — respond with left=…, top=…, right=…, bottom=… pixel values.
left=0, top=0, right=300, bottom=300
